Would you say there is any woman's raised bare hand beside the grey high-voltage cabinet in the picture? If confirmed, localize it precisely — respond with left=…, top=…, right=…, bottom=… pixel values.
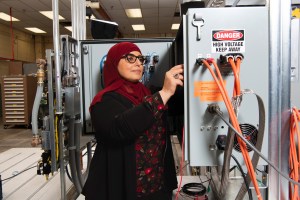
left=159, top=64, right=183, bottom=104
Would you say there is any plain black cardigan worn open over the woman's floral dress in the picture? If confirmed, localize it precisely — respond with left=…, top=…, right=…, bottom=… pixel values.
left=82, top=92, right=177, bottom=200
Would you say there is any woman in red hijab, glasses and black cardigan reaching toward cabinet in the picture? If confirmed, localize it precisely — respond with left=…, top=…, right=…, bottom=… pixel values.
left=82, top=42, right=183, bottom=200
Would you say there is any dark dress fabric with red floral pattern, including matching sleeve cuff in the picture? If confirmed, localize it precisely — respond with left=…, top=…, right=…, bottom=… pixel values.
left=135, top=94, right=167, bottom=197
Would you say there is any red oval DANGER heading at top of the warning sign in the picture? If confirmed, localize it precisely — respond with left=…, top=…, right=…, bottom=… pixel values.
left=213, top=30, right=244, bottom=41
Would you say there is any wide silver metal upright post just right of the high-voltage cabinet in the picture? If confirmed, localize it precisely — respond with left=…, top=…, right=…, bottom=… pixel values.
left=267, top=0, right=291, bottom=199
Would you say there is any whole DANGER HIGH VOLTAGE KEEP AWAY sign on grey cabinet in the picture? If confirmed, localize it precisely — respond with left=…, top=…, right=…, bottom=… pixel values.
left=211, top=30, right=245, bottom=53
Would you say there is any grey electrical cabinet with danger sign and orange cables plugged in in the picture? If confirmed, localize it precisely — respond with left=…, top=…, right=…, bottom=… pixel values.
left=183, top=7, right=271, bottom=166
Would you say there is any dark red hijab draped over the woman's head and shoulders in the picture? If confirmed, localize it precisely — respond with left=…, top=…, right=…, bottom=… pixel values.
left=90, top=42, right=151, bottom=111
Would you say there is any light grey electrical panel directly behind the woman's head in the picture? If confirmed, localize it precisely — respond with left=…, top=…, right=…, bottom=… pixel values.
left=80, top=39, right=173, bottom=133
